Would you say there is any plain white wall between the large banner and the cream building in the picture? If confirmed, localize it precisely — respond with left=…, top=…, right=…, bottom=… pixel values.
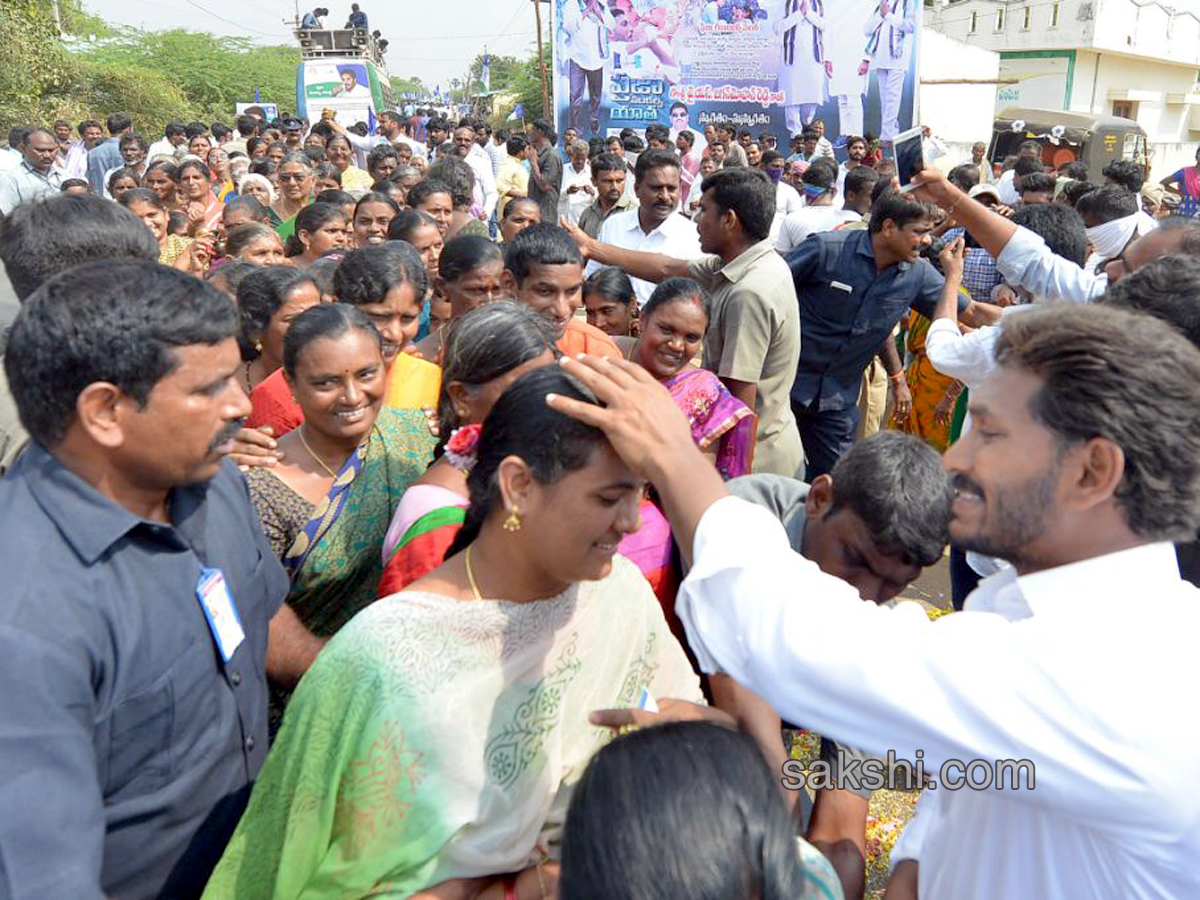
left=918, top=29, right=1000, bottom=166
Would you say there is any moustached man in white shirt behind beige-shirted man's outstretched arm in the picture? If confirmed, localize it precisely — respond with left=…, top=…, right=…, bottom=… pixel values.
left=587, top=150, right=700, bottom=305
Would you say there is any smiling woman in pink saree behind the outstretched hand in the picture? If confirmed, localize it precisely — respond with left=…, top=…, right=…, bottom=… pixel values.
left=619, top=278, right=756, bottom=634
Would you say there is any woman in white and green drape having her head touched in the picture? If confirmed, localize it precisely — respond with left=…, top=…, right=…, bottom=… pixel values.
left=204, top=366, right=703, bottom=900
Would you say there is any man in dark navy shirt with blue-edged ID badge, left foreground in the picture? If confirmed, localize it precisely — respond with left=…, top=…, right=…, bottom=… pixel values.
left=0, top=259, right=288, bottom=900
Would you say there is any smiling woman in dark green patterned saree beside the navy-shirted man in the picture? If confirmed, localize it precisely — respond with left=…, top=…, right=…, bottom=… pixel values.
left=246, top=304, right=434, bottom=715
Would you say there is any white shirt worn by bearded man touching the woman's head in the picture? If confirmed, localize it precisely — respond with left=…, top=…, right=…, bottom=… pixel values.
left=676, top=497, right=1200, bottom=900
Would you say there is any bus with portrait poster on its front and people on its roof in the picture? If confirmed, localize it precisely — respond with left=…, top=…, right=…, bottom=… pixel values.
left=295, top=28, right=397, bottom=130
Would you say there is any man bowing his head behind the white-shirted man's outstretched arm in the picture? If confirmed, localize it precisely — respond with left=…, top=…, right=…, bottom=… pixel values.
left=713, top=431, right=953, bottom=898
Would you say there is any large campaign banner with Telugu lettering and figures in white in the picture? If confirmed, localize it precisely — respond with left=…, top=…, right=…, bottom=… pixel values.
left=552, top=0, right=920, bottom=149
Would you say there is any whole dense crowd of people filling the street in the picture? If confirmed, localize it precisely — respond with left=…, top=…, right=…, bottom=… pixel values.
left=0, top=90, right=1200, bottom=900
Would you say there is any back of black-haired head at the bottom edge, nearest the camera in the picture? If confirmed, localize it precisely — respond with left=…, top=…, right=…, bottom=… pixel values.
left=556, top=724, right=809, bottom=900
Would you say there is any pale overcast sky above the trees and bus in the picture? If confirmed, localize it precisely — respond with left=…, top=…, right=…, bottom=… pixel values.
left=84, top=0, right=548, bottom=90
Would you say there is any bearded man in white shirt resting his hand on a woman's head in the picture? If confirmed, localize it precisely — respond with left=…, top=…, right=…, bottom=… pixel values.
left=551, top=297, right=1200, bottom=900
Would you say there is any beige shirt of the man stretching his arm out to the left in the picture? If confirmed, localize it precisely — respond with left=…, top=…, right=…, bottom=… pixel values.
left=688, top=240, right=804, bottom=478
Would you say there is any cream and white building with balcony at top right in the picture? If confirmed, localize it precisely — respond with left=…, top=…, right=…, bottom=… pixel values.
left=922, top=0, right=1200, bottom=181
